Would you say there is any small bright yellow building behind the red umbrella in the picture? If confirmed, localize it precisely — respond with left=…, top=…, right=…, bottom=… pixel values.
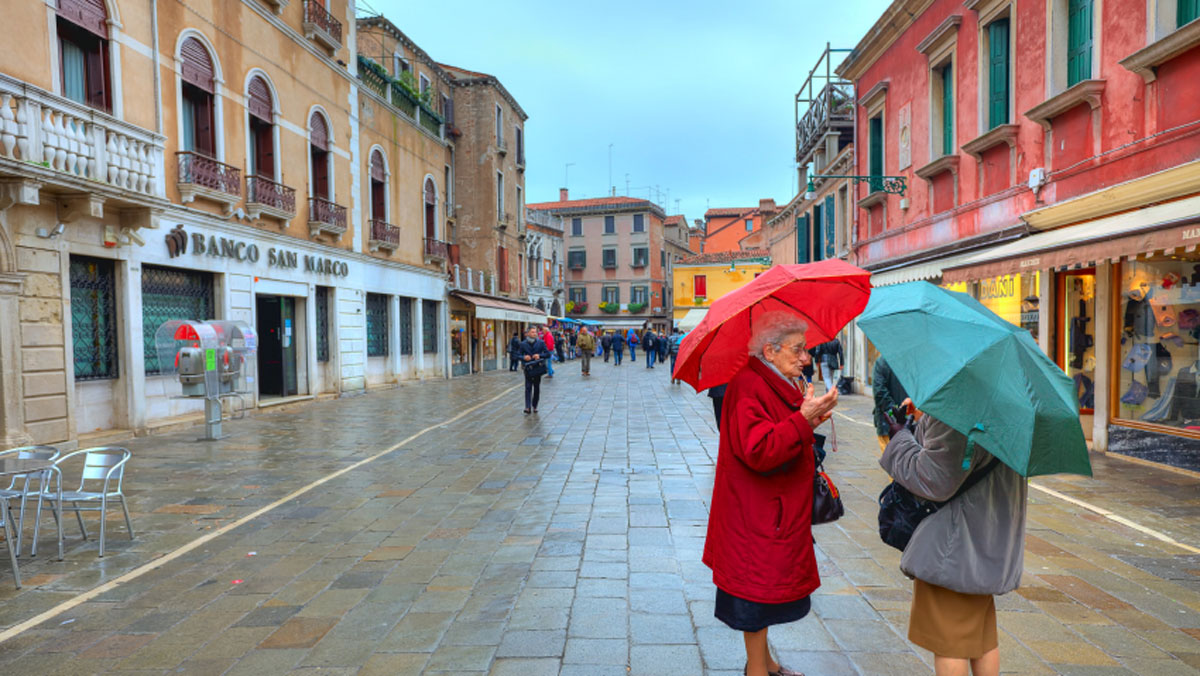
left=672, top=249, right=770, bottom=331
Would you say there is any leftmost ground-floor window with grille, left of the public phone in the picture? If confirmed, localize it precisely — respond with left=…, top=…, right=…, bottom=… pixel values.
left=71, top=256, right=117, bottom=382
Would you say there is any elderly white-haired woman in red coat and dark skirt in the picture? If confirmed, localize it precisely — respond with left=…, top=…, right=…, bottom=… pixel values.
left=703, top=312, right=838, bottom=676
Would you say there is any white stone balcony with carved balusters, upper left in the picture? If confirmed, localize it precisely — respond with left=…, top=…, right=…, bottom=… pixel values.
left=0, top=73, right=167, bottom=225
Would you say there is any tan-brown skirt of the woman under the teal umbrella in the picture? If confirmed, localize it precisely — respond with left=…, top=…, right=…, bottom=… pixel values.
left=908, top=580, right=1000, bottom=659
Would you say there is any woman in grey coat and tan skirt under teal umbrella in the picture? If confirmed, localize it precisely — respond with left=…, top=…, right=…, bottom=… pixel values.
left=880, top=414, right=1028, bottom=676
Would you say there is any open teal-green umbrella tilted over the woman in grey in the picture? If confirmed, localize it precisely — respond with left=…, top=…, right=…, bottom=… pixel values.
left=858, top=282, right=1092, bottom=477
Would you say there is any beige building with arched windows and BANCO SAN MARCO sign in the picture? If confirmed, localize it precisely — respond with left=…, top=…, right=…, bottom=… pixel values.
left=0, top=0, right=535, bottom=444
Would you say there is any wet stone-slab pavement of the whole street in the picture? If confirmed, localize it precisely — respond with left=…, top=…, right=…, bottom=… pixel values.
left=0, top=360, right=1200, bottom=676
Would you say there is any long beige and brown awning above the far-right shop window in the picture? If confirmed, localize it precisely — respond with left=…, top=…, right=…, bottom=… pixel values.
left=942, top=197, right=1200, bottom=282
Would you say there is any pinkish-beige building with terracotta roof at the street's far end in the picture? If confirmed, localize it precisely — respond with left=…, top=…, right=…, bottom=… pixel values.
left=529, top=189, right=671, bottom=330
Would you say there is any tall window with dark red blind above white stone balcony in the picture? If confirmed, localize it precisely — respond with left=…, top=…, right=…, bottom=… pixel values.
left=58, top=0, right=113, bottom=110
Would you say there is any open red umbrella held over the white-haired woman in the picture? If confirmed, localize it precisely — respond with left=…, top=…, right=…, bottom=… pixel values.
left=674, top=258, right=871, bottom=390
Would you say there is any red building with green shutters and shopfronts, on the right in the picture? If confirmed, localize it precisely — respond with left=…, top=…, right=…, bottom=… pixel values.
left=838, top=0, right=1200, bottom=469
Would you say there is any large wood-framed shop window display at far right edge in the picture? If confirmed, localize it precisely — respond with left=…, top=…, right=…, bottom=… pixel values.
left=1117, top=257, right=1200, bottom=431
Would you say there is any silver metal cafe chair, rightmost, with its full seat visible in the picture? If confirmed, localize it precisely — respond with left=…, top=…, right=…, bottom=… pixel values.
left=32, top=447, right=133, bottom=557
